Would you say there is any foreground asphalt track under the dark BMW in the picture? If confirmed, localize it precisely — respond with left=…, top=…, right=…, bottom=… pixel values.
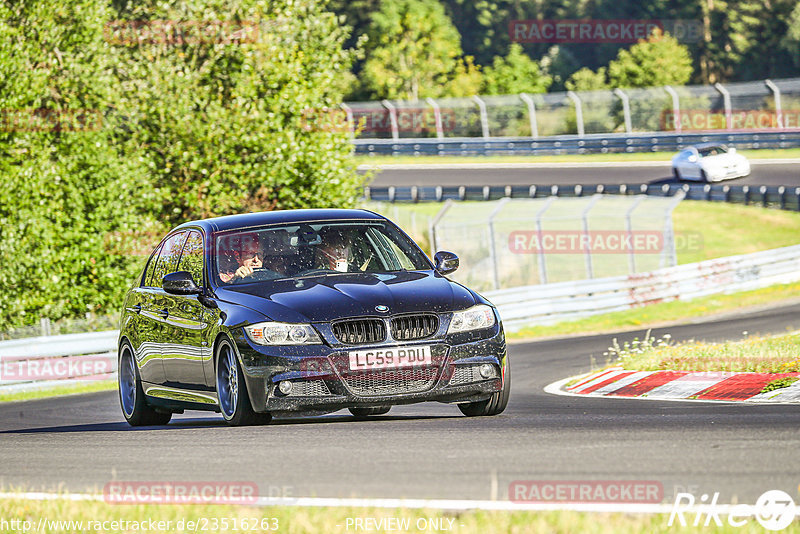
left=0, top=304, right=800, bottom=504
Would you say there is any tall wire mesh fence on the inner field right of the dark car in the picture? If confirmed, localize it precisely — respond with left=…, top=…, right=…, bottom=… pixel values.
left=430, top=192, right=683, bottom=291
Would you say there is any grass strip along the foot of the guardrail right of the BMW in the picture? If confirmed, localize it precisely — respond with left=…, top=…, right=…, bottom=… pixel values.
left=506, top=282, right=800, bottom=340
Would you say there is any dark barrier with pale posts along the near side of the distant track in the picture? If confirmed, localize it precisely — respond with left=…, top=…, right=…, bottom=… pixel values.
left=364, top=183, right=800, bottom=211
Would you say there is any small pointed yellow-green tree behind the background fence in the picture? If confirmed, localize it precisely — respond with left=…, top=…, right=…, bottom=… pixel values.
left=483, top=43, right=553, bottom=95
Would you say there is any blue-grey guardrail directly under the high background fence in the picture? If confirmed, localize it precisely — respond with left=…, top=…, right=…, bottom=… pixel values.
left=353, top=131, right=800, bottom=156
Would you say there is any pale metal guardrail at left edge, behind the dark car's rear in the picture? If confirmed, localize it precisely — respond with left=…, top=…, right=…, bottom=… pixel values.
left=0, top=330, right=119, bottom=392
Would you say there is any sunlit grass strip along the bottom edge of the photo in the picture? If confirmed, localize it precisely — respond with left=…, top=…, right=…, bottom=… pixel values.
left=0, top=499, right=800, bottom=534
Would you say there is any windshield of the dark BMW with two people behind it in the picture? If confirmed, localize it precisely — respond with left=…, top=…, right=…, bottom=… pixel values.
left=209, top=221, right=430, bottom=285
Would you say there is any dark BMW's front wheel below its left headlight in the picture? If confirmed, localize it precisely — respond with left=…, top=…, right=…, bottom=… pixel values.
left=216, top=339, right=272, bottom=426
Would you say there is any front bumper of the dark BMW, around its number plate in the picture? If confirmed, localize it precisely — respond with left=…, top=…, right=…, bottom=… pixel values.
left=234, top=322, right=507, bottom=415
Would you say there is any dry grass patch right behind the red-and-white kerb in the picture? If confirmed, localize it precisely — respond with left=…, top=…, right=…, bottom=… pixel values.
left=603, top=332, right=800, bottom=372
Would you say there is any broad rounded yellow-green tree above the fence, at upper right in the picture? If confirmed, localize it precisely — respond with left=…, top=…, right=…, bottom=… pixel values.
left=608, top=31, right=692, bottom=87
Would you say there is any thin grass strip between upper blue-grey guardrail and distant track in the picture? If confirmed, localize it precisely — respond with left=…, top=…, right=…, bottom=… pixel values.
left=355, top=148, right=800, bottom=165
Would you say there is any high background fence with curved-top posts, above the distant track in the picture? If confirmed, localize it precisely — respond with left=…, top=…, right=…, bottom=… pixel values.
left=342, top=78, right=800, bottom=144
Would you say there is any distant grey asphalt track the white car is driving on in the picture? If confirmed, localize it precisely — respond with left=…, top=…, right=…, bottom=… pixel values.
left=371, top=160, right=800, bottom=187
